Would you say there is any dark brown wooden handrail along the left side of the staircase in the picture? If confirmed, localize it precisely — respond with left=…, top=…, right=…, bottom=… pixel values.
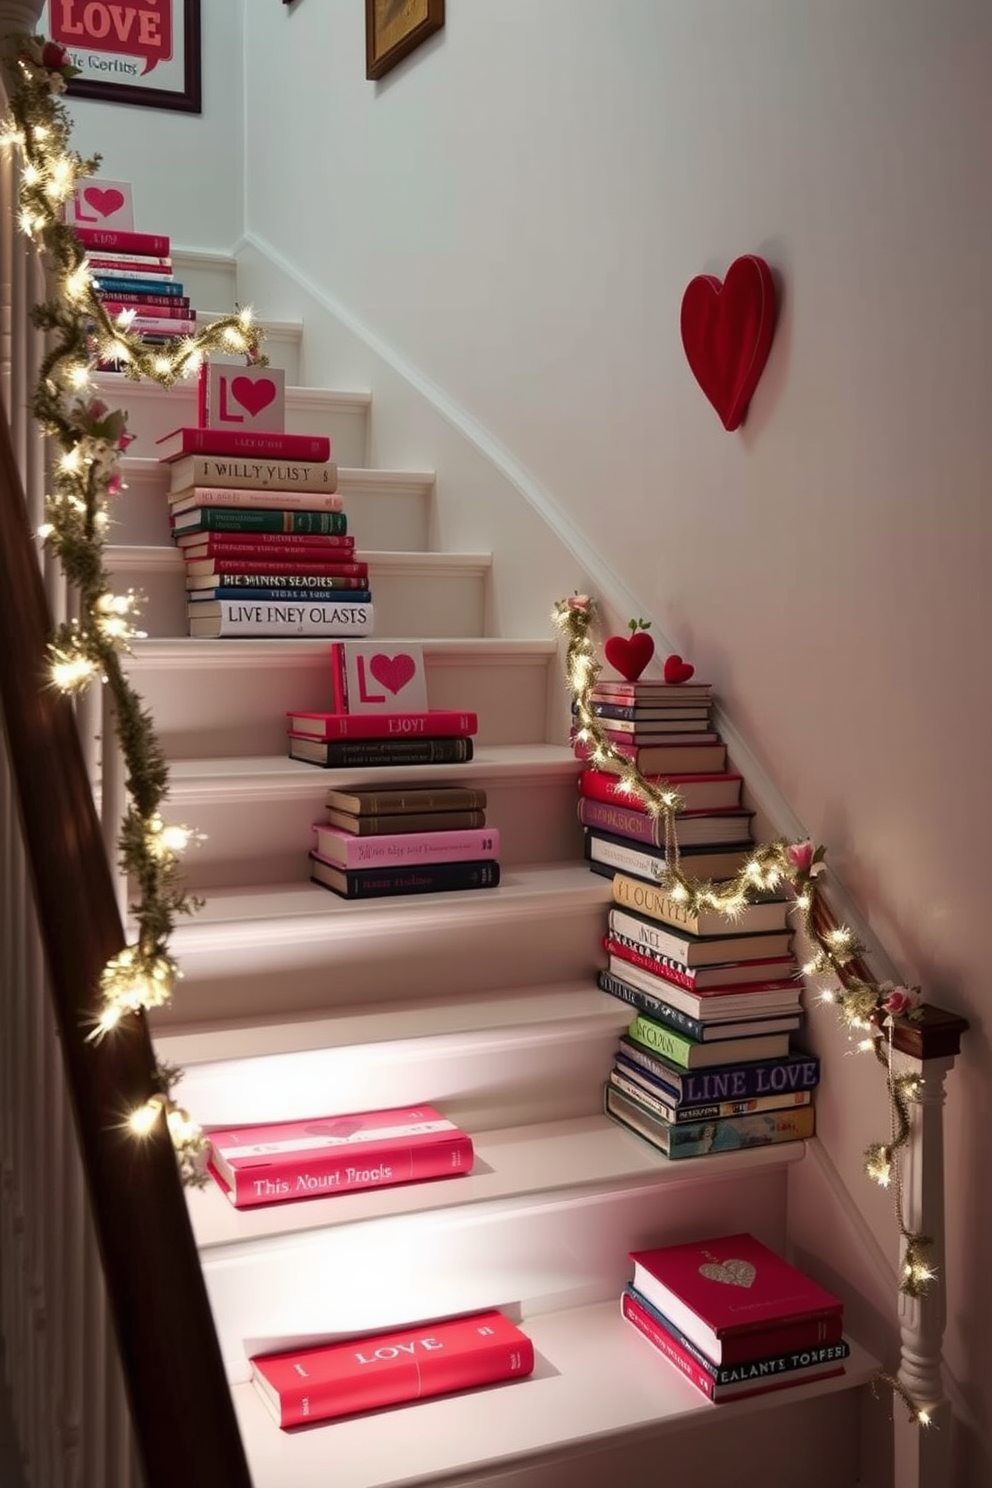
left=0, top=412, right=251, bottom=1488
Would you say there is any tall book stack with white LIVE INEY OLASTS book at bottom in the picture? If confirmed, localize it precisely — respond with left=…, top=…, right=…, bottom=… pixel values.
left=158, top=427, right=373, bottom=637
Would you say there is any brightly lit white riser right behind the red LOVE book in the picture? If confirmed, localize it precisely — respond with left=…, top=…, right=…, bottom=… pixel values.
left=201, top=1170, right=785, bottom=1384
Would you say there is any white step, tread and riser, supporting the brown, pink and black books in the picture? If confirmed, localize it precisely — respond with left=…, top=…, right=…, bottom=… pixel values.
left=152, top=863, right=610, bottom=1036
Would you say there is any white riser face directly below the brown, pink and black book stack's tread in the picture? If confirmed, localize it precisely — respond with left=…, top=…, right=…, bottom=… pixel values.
left=153, top=898, right=602, bottom=1031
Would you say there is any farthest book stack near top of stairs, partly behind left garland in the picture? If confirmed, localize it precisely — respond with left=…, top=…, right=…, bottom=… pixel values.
left=76, top=226, right=196, bottom=342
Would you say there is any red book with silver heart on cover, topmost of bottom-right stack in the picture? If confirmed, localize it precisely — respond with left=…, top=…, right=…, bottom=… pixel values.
left=631, top=1232, right=843, bottom=1364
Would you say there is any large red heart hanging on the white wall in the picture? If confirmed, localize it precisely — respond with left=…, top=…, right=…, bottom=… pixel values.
left=681, top=253, right=775, bottom=430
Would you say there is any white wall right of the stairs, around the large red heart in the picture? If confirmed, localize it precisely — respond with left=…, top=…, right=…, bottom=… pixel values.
left=240, top=0, right=992, bottom=1485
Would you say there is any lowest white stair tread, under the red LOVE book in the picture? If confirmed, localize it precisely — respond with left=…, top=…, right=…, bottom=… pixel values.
left=232, top=1302, right=879, bottom=1488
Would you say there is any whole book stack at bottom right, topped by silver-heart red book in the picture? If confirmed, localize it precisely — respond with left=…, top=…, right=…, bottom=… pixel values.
left=620, top=1232, right=851, bottom=1403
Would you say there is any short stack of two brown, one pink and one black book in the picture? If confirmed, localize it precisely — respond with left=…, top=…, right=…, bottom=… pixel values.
left=309, top=784, right=500, bottom=899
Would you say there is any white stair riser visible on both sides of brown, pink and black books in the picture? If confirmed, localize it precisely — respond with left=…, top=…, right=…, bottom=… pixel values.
left=144, top=769, right=582, bottom=893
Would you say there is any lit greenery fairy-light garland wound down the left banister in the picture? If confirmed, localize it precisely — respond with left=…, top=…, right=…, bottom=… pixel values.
left=0, top=36, right=266, bottom=1183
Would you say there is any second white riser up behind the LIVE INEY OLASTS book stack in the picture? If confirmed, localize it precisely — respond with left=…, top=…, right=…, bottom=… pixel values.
left=109, top=457, right=434, bottom=552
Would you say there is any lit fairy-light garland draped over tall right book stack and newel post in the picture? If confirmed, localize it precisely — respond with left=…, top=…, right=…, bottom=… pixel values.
left=552, top=594, right=935, bottom=1426
